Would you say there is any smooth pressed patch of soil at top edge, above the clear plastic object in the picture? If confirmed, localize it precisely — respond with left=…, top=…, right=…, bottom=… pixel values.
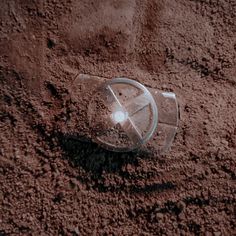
left=63, top=0, right=135, bottom=61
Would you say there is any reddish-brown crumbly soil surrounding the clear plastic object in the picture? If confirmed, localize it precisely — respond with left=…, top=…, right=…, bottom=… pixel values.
left=0, top=0, right=236, bottom=236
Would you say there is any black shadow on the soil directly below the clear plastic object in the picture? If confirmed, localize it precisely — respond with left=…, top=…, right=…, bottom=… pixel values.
left=57, top=134, right=175, bottom=193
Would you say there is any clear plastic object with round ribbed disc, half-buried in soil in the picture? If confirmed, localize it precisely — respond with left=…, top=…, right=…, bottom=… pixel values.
left=68, top=74, right=178, bottom=153
